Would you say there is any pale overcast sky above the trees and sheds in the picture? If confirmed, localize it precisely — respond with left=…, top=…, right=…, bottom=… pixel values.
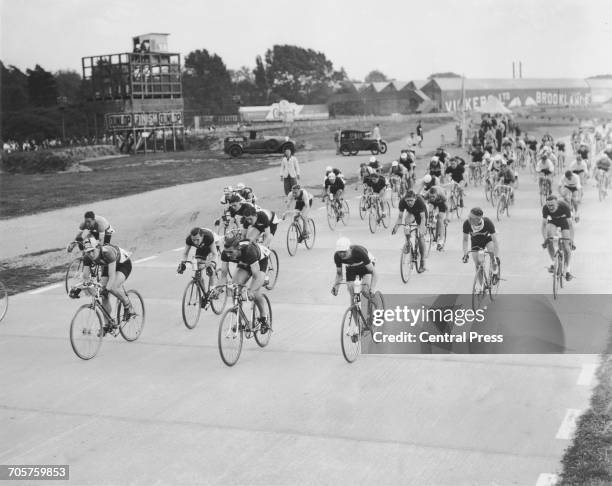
left=0, top=0, right=612, bottom=81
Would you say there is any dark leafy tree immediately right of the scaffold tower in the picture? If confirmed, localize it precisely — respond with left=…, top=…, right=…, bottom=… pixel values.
left=183, top=49, right=236, bottom=115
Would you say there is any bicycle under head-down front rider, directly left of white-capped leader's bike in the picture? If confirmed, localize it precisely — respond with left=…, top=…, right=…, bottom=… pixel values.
left=217, top=283, right=272, bottom=366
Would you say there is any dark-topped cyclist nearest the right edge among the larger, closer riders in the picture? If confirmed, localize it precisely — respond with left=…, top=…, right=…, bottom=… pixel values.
left=542, top=194, right=576, bottom=280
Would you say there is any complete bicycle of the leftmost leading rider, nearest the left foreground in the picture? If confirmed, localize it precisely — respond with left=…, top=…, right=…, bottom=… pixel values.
left=70, top=281, right=145, bottom=360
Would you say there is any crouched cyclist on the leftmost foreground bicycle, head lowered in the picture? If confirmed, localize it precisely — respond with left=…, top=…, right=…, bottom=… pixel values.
left=70, top=238, right=136, bottom=331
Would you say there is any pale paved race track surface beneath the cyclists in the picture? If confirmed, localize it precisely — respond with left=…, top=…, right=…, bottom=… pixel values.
left=0, top=127, right=612, bottom=485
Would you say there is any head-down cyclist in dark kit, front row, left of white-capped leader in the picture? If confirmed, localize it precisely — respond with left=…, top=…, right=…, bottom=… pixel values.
left=223, top=233, right=270, bottom=334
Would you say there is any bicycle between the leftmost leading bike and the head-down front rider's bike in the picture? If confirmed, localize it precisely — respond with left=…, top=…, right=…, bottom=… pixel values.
left=181, top=260, right=232, bottom=329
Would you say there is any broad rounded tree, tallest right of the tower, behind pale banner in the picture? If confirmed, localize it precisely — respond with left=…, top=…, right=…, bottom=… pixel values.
left=262, top=45, right=338, bottom=103
